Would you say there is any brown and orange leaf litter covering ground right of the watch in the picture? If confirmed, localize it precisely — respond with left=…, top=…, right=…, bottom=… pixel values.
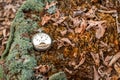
left=0, top=0, right=120, bottom=80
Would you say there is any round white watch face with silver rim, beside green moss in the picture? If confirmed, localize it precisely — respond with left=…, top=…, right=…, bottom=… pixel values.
left=32, top=33, right=52, bottom=50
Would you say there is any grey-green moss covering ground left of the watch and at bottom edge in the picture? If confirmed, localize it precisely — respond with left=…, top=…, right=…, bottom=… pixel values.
left=0, top=0, right=66, bottom=80
